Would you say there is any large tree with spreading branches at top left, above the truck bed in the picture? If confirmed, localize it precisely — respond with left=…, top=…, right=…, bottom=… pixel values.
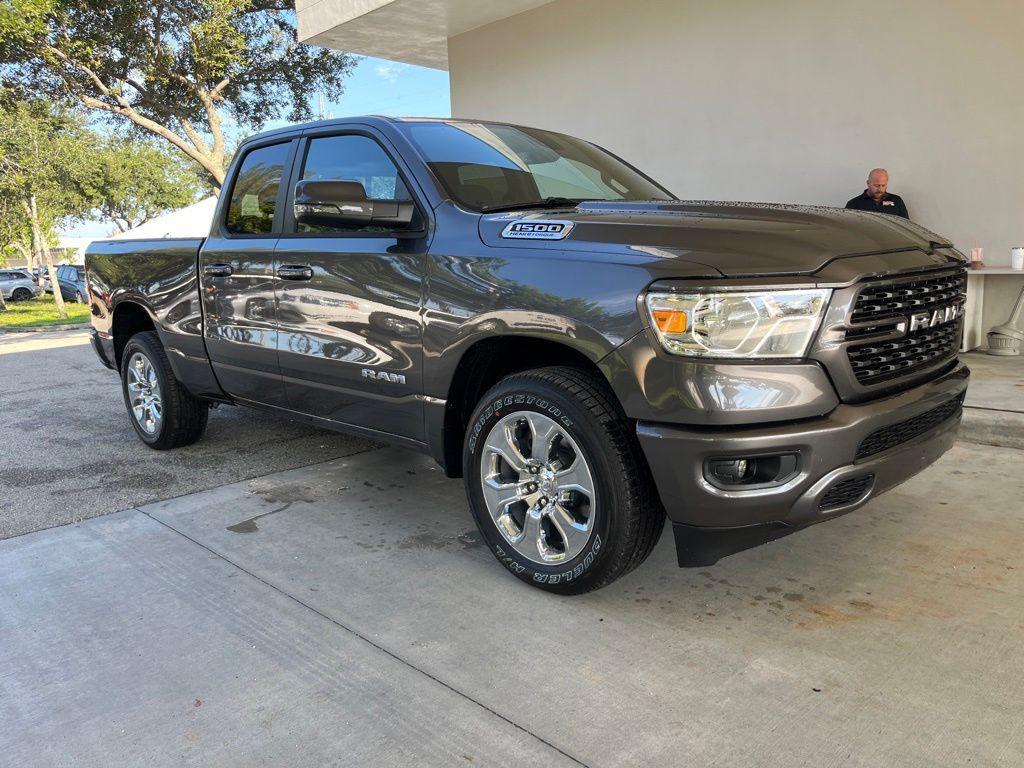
left=0, top=0, right=354, bottom=187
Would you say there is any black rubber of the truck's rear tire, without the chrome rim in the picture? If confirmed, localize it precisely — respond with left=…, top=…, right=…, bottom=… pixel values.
left=121, top=331, right=210, bottom=451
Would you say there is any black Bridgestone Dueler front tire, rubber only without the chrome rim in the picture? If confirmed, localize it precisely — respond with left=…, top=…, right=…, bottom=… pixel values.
left=463, top=368, right=665, bottom=595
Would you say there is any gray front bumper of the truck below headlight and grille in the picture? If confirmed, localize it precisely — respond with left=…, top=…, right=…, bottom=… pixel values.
left=637, top=362, right=970, bottom=566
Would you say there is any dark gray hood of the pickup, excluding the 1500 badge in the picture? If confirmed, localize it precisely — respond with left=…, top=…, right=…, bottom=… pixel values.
left=480, top=201, right=952, bottom=278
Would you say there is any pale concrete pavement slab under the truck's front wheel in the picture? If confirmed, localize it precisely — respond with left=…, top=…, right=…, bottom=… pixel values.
left=6, top=331, right=1024, bottom=768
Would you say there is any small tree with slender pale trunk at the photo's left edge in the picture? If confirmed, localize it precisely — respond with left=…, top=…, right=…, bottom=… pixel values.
left=0, top=99, right=95, bottom=317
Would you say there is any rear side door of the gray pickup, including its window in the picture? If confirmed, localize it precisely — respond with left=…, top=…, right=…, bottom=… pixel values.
left=200, top=141, right=296, bottom=407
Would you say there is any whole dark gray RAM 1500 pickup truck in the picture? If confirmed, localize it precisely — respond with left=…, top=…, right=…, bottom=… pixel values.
left=86, top=118, right=970, bottom=594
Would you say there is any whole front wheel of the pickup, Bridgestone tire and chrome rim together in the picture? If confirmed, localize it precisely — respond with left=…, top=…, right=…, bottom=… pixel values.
left=463, top=368, right=665, bottom=594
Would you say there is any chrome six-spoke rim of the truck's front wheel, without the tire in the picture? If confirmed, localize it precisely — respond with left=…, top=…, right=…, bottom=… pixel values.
left=480, top=411, right=597, bottom=565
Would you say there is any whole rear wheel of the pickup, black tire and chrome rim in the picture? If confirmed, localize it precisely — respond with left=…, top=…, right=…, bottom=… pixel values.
left=121, top=331, right=210, bottom=451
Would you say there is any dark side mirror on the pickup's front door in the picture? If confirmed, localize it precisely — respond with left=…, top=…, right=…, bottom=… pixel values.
left=294, top=179, right=416, bottom=229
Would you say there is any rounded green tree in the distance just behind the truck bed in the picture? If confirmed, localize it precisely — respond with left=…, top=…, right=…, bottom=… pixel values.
left=87, top=136, right=210, bottom=232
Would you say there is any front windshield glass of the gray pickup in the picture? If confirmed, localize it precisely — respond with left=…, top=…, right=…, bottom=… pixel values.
left=401, top=121, right=672, bottom=212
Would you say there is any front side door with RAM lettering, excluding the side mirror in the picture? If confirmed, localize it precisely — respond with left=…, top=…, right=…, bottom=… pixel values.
left=274, top=129, right=427, bottom=440
